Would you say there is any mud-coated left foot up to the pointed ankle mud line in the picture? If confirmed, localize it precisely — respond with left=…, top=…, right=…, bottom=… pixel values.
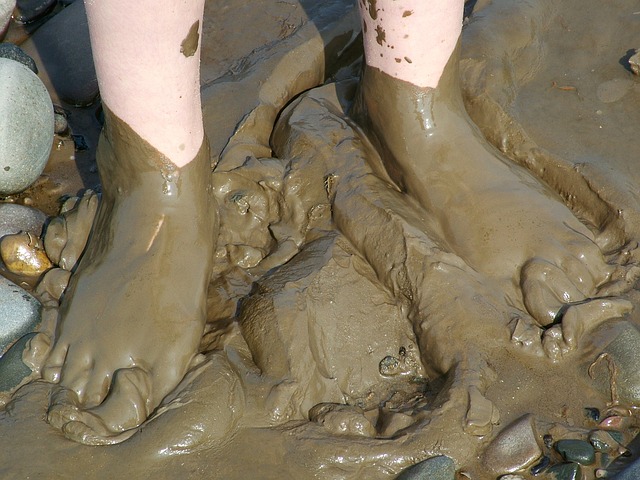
left=42, top=109, right=217, bottom=444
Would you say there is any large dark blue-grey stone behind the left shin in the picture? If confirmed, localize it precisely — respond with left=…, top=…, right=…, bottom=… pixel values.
left=21, top=2, right=98, bottom=107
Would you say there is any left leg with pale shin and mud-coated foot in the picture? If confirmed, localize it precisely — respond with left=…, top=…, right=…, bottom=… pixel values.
left=42, top=0, right=217, bottom=444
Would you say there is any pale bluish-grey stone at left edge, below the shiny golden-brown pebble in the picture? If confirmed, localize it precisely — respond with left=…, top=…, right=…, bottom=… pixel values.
left=0, top=277, right=42, bottom=353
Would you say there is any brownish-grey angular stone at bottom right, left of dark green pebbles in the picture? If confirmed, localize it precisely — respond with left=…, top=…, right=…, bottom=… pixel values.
left=483, top=415, right=542, bottom=475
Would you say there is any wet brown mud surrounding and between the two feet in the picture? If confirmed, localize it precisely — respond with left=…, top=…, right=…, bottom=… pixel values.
left=0, top=0, right=640, bottom=479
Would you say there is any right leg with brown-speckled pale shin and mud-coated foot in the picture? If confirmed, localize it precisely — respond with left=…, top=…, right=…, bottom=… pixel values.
left=356, top=0, right=631, bottom=352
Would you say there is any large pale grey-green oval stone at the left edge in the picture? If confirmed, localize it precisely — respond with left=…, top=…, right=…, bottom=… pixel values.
left=0, top=58, right=54, bottom=195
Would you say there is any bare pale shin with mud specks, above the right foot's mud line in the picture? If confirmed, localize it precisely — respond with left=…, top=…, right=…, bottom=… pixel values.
left=358, top=0, right=464, bottom=88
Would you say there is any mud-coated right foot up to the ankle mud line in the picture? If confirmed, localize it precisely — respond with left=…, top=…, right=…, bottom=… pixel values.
left=355, top=45, right=628, bottom=350
